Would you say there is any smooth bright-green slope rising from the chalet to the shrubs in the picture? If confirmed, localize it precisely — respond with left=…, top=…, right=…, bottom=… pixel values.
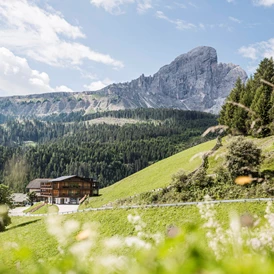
left=80, top=140, right=216, bottom=208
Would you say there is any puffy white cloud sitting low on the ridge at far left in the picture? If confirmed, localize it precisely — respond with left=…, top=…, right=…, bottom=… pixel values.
left=0, top=47, right=71, bottom=96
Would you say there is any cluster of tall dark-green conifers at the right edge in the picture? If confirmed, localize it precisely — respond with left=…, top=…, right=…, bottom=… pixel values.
left=219, top=58, right=274, bottom=137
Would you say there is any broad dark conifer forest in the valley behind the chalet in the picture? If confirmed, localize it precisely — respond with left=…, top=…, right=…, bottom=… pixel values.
left=0, top=109, right=217, bottom=191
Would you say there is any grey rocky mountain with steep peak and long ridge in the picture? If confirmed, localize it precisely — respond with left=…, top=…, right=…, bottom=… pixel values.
left=0, top=46, right=247, bottom=116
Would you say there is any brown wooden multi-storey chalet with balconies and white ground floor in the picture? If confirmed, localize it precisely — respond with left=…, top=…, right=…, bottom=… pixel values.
left=38, top=175, right=99, bottom=204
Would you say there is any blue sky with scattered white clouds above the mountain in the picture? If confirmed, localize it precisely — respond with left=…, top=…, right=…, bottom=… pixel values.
left=0, top=0, right=274, bottom=97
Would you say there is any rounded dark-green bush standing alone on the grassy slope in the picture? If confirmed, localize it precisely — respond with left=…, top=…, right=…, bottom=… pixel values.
left=226, top=137, right=261, bottom=179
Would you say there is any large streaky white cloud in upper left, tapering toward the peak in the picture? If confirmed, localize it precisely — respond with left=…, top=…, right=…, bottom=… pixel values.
left=0, top=0, right=123, bottom=68
